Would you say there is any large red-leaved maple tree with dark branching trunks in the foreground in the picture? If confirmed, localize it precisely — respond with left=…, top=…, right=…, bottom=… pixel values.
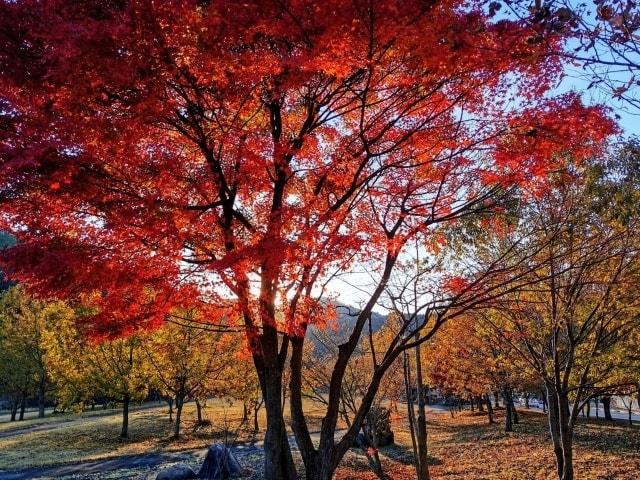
left=0, top=0, right=613, bottom=479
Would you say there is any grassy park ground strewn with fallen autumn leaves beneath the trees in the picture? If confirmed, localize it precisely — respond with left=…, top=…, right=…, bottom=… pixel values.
left=0, top=401, right=640, bottom=480
